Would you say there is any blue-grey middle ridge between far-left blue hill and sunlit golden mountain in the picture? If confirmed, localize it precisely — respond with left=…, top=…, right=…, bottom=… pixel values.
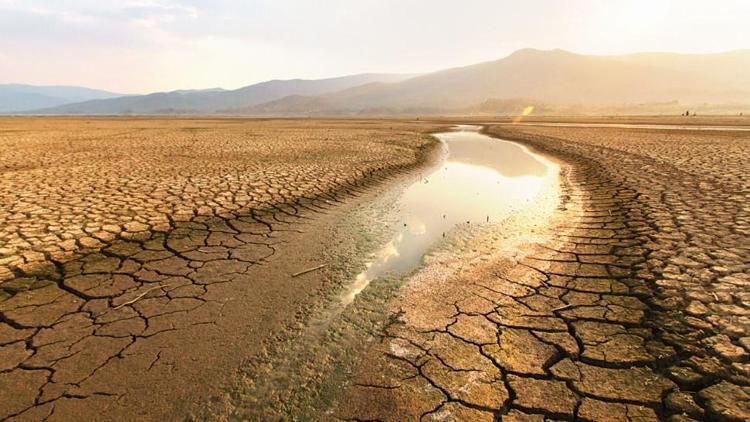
left=29, top=73, right=411, bottom=114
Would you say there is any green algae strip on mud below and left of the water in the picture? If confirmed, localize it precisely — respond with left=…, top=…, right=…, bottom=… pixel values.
left=219, top=176, right=418, bottom=420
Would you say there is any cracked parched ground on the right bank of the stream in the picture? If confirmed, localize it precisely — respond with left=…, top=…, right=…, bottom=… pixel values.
left=337, top=125, right=750, bottom=421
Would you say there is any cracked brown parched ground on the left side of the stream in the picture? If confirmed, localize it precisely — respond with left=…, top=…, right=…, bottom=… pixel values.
left=0, top=118, right=440, bottom=420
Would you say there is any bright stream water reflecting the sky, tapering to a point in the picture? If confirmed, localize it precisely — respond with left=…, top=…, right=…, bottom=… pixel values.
left=342, top=126, right=550, bottom=304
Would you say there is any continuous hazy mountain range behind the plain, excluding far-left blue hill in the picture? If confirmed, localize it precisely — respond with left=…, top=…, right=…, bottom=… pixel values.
left=5, top=49, right=750, bottom=116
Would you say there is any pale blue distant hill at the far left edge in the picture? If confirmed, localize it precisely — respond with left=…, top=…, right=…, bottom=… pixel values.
left=0, top=84, right=122, bottom=113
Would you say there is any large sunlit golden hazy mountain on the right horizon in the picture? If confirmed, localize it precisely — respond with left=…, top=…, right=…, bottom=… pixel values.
left=235, top=49, right=750, bottom=115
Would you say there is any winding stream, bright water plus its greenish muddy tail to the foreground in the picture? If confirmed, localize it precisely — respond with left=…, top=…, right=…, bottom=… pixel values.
left=239, top=125, right=559, bottom=420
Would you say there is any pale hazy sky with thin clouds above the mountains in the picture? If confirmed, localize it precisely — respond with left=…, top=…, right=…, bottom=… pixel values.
left=0, top=0, right=750, bottom=93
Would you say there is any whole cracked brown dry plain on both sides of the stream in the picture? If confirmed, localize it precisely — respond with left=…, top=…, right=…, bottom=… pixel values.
left=0, top=118, right=750, bottom=421
